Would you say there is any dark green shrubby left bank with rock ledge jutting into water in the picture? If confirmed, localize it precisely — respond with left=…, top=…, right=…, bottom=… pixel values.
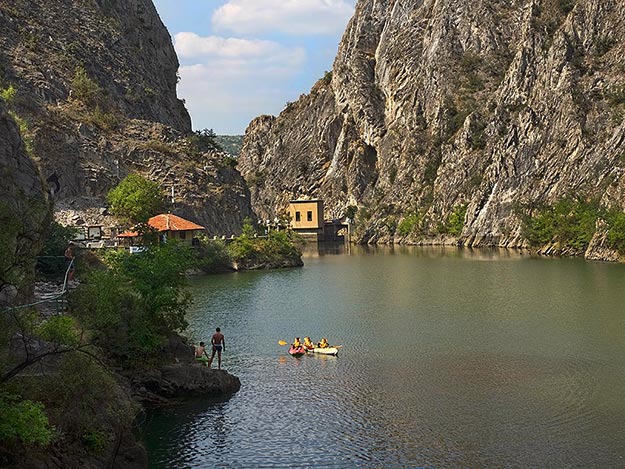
left=0, top=221, right=303, bottom=468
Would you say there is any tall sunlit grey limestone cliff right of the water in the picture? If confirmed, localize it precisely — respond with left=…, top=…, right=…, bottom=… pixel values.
left=240, top=0, right=625, bottom=257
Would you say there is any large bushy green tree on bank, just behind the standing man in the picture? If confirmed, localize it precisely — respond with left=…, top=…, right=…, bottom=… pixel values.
left=74, top=242, right=193, bottom=367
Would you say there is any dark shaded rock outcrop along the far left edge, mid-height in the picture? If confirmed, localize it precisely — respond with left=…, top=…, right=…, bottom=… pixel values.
left=0, top=101, right=51, bottom=308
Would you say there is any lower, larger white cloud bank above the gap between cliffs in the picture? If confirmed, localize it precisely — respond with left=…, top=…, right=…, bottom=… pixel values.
left=174, top=32, right=306, bottom=134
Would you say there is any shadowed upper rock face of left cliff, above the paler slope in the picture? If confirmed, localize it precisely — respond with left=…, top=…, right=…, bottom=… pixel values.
left=0, top=0, right=191, bottom=132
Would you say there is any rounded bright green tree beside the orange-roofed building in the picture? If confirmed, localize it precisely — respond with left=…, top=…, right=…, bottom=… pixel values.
left=107, top=174, right=165, bottom=229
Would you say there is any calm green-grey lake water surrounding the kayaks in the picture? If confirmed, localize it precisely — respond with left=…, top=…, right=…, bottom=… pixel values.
left=142, top=248, right=625, bottom=468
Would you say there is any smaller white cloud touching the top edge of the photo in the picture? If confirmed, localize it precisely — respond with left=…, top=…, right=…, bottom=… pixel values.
left=212, top=0, right=354, bottom=35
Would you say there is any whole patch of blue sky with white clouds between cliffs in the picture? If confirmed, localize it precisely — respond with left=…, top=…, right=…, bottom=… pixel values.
left=154, top=0, right=356, bottom=135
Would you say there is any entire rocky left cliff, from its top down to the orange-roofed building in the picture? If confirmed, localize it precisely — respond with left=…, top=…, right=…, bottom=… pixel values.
left=0, top=0, right=252, bottom=234
